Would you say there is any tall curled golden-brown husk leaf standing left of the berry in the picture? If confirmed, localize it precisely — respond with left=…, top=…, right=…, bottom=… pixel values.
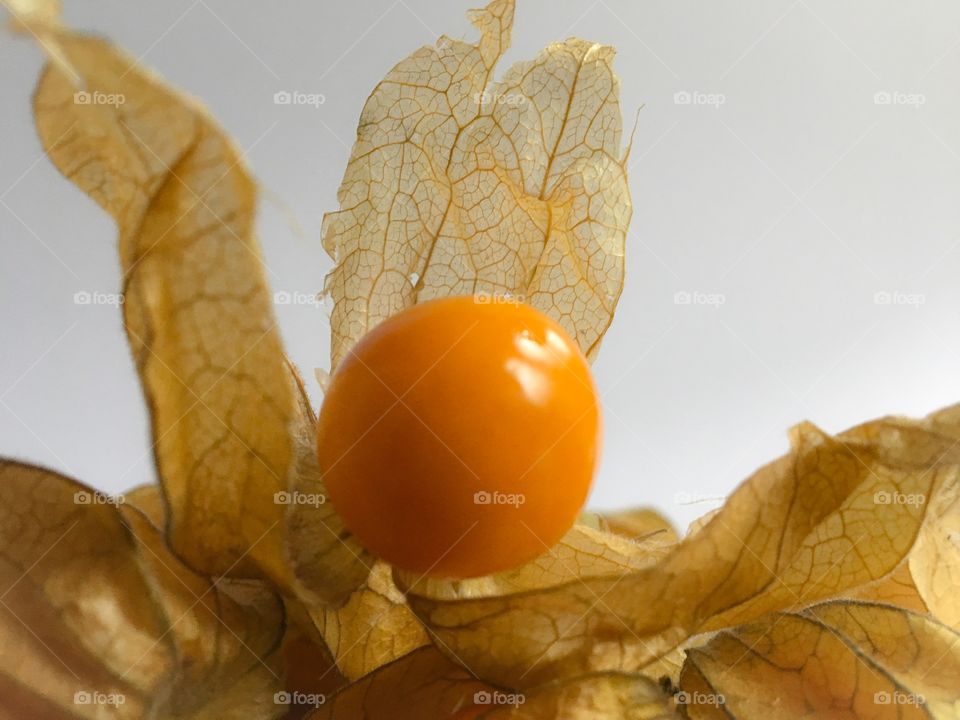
left=34, top=21, right=295, bottom=583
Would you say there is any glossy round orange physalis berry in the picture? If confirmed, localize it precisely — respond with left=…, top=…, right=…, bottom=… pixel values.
left=318, top=297, right=600, bottom=578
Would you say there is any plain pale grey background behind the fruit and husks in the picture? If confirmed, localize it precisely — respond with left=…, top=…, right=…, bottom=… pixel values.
left=0, top=0, right=960, bottom=524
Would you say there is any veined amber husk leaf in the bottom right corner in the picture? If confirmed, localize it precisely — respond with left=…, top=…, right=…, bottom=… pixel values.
left=680, top=601, right=960, bottom=720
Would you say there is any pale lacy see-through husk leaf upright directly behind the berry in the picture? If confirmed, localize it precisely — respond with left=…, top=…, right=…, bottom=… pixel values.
left=323, top=0, right=631, bottom=366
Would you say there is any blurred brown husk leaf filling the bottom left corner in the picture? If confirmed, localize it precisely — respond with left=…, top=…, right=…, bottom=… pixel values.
left=0, top=461, right=284, bottom=720
